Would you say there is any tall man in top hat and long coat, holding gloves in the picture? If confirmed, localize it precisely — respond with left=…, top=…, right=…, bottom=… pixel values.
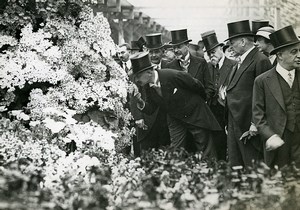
left=226, top=20, right=271, bottom=166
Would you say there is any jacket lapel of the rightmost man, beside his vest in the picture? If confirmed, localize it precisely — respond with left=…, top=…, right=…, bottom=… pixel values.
left=267, top=67, right=285, bottom=111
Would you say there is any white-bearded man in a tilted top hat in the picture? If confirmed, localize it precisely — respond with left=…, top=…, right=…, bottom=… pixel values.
left=201, top=31, right=236, bottom=160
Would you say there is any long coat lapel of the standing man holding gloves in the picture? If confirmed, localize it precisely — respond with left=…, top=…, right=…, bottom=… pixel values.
left=227, top=48, right=258, bottom=90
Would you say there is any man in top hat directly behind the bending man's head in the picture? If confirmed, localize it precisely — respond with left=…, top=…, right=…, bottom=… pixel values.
left=133, top=33, right=170, bottom=155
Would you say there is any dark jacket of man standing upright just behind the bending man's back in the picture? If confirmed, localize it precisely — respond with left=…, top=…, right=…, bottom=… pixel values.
left=165, top=55, right=214, bottom=101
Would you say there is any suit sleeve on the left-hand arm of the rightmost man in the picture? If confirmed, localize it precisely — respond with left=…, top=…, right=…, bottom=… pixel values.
left=252, top=77, right=275, bottom=139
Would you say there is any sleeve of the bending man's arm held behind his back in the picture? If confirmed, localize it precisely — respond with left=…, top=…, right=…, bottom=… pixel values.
left=175, top=71, right=206, bottom=99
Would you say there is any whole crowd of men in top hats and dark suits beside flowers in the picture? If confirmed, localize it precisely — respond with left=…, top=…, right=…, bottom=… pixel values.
left=119, top=20, right=300, bottom=168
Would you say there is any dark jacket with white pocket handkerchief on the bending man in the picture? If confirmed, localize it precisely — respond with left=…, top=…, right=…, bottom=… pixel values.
left=142, top=69, right=221, bottom=130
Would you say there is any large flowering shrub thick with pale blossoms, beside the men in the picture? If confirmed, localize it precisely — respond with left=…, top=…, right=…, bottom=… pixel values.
left=0, top=0, right=133, bottom=153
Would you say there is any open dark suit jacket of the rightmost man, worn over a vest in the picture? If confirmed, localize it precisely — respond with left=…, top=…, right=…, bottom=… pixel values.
left=252, top=67, right=300, bottom=165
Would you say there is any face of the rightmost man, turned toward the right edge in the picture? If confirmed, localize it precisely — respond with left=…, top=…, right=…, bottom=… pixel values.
left=278, top=43, right=300, bottom=70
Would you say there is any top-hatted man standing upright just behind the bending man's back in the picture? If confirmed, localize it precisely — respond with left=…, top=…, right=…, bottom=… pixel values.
left=166, top=29, right=214, bottom=101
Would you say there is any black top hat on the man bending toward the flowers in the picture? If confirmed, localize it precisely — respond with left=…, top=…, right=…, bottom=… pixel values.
left=130, top=52, right=154, bottom=74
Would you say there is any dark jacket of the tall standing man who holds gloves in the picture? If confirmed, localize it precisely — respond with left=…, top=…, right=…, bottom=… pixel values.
left=226, top=48, right=271, bottom=136
